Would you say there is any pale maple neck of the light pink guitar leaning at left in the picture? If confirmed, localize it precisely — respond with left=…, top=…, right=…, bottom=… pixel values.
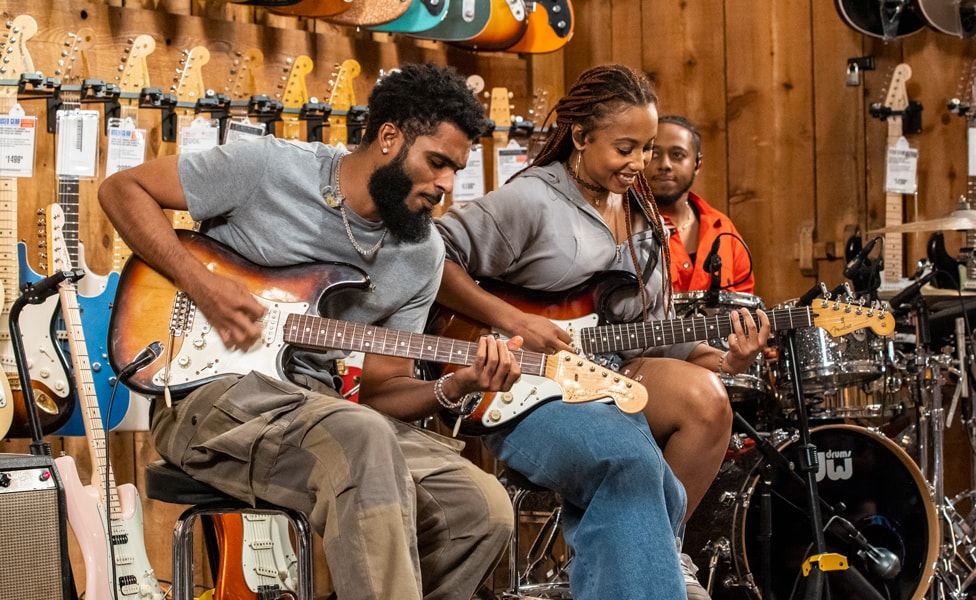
left=58, top=281, right=122, bottom=521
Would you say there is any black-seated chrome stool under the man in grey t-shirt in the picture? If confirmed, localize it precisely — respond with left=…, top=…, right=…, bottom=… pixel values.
left=145, top=460, right=313, bottom=600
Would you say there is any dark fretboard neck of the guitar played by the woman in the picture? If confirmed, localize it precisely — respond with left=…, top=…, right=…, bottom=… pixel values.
left=580, top=306, right=814, bottom=354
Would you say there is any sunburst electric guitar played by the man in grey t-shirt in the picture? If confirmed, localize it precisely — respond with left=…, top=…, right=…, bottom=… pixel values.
left=109, top=230, right=647, bottom=420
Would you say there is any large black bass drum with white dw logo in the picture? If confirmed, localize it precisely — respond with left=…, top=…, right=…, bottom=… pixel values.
left=683, top=425, right=939, bottom=600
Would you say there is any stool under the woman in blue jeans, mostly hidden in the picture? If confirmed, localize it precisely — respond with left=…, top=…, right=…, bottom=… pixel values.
left=501, top=467, right=573, bottom=600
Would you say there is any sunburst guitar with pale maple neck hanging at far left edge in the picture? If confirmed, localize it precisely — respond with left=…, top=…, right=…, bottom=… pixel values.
left=0, top=15, right=74, bottom=437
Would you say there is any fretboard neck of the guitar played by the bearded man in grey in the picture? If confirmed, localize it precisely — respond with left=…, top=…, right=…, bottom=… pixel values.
left=284, top=313, right=549, bottom=376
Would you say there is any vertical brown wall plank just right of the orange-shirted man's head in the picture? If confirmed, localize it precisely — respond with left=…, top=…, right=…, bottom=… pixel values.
left=726, top=0, right=815, bottom=303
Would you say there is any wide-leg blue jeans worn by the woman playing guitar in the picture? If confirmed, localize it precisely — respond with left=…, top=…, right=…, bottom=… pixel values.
left=484, top=401, right=687, bottom=600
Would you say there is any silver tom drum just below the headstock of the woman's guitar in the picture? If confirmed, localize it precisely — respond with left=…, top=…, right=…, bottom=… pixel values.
left=775, top=301, right=885, bottom=396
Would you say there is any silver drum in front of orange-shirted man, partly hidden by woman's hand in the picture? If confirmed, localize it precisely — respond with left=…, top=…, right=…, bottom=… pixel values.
left=673, top=290, right=770, bottom=402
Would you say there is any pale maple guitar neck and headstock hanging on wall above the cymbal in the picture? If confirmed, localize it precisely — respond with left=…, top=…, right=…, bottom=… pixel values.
left=880, top=63, right=912, bottom=292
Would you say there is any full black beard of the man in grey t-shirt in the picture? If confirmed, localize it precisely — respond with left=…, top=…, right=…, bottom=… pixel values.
left=368, top=156, right=433, bottom=244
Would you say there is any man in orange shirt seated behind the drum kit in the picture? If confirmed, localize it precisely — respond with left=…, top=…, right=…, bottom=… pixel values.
left=644, top=115, right=755, bottom=294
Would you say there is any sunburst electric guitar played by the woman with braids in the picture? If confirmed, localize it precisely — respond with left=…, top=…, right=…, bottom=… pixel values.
left=427, top=271, right=895, bottom=434
